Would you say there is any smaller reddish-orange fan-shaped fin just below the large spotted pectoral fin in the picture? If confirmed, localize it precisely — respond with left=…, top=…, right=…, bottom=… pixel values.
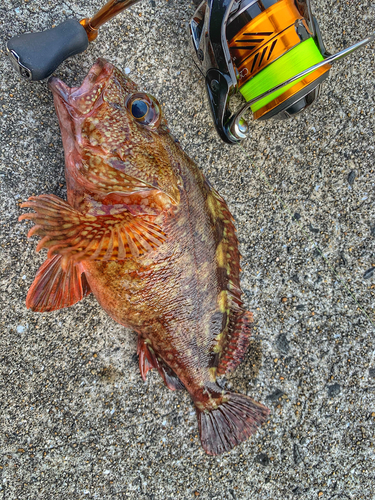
left=26, top=255, right=91, bottom=312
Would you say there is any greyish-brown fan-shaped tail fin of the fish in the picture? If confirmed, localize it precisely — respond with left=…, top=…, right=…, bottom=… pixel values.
left=196, top=392, right=270, bottom=455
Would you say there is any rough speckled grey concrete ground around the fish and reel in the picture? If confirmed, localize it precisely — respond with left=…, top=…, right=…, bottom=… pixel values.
left=0, top=0, right=375, bottom=500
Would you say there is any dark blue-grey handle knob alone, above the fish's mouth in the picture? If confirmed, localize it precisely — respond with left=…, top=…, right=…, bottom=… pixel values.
left=7, top=19, right=89, bottom=80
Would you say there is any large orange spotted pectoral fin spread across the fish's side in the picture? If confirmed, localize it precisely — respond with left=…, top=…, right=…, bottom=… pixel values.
left=19, top=195, right=166, bottom=269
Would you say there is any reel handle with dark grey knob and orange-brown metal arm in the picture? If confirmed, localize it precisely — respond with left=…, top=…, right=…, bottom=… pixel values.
left=7, top=0, right=139, bottom=81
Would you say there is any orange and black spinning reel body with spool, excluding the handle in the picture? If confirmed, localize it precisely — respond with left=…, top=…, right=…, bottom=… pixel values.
left=190, top=0, right=375, bottom=144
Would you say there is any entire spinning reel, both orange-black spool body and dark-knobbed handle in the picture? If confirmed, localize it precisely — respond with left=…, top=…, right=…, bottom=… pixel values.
left=7, top=0, right=375, bottom=144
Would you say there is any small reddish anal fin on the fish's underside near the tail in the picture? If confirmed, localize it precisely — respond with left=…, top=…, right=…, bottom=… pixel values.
left=137, top=336, right=185, bottom=391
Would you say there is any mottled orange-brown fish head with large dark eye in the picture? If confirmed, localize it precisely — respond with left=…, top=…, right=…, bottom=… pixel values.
left=49, top=59, right=186, bottom=207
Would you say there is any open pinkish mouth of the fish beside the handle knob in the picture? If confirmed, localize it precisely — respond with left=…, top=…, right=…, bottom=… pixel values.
left=48, top=58, right=114, bottom=107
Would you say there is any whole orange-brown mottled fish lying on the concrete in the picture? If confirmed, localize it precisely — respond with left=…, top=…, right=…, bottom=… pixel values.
left=19, top=59, right=269, bottom=455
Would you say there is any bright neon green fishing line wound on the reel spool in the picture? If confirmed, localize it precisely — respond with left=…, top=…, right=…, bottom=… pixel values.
left=240, top=38, right=324, bottom=113
